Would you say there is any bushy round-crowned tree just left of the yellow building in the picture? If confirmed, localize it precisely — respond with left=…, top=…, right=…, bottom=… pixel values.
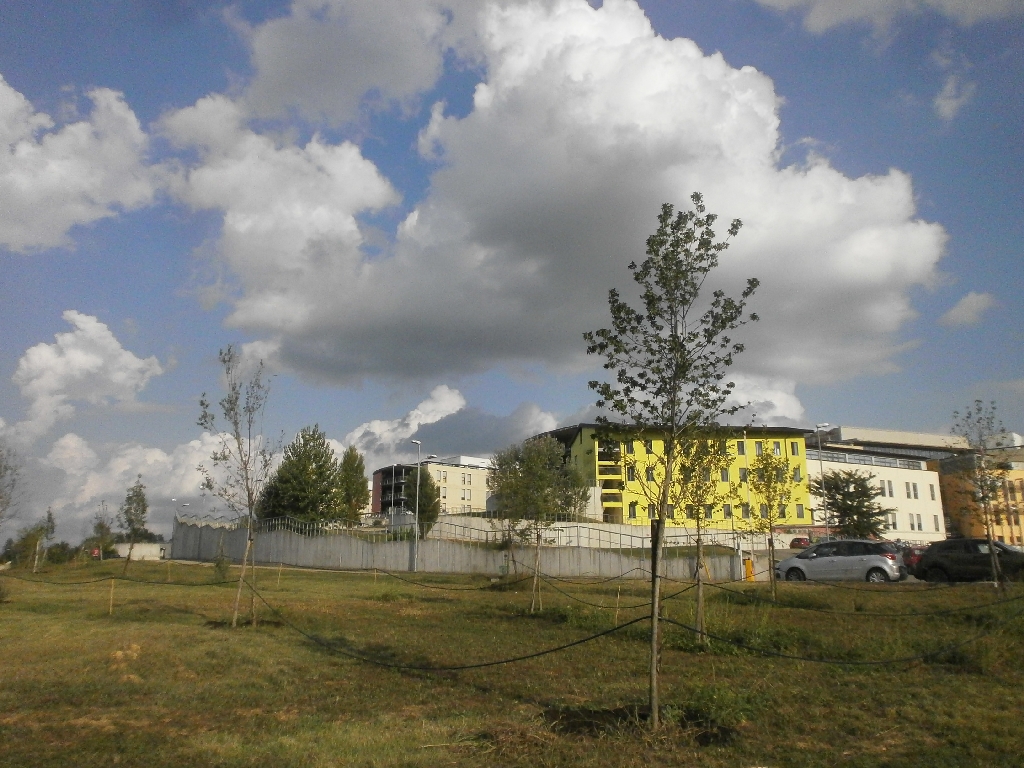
left=487, top=436, right=590, bottom=612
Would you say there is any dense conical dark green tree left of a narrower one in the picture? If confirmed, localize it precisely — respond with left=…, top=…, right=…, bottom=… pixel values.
left=257, top=425, right=345, bottom=520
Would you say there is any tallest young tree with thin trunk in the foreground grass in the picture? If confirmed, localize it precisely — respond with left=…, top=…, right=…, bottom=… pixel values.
left=584, top=193, right=758, bottom=728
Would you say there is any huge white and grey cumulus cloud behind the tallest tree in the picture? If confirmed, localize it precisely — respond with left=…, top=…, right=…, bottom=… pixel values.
left=172, top=0, right=945, bottom=423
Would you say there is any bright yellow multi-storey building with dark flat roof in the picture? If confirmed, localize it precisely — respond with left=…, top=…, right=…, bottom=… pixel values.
left=545, top=424, right=813, bottom=531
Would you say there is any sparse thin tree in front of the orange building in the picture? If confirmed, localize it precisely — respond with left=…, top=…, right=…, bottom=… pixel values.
left=951, top=400, right=1010, bottom=591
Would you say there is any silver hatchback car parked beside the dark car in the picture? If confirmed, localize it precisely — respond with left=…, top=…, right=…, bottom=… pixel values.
left=775, top=539, right=906, bottom=583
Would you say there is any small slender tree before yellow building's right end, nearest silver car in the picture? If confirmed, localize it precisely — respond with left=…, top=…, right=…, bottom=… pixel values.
left=746, top=437, right=802, bottom=600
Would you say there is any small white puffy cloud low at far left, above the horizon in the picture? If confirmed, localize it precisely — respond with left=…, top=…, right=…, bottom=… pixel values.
left=6, top=309, right=163, bottom=442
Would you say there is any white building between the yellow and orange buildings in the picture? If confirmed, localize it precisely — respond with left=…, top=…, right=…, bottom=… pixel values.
left=807, top=438, right=946, bottom=544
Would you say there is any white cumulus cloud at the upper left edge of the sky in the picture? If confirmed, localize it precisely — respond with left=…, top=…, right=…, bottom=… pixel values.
left=0, top=77, right=157, bottom=251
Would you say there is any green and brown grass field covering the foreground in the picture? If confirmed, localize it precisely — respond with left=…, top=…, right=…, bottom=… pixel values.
left=0, top=563, right=1024, bottom=768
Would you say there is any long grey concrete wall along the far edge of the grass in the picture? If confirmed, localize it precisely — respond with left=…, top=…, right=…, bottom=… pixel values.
left=171, top=522, right=742, bottom=581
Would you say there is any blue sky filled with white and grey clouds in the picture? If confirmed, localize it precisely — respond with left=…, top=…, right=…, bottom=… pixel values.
left=0, top=0, right=1024, bottom=541
